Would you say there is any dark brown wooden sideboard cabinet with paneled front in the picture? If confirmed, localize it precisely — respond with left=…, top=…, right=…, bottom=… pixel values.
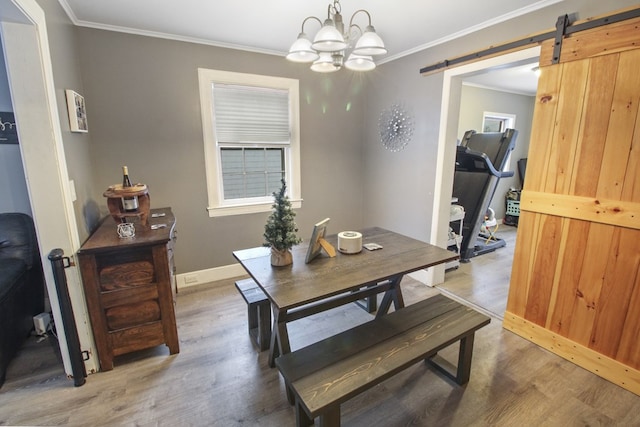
left=78, top=208, right=180, bottom=371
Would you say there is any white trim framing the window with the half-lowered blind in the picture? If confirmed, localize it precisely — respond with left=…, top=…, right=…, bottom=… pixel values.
left=198, top=68, right=302, bottom=217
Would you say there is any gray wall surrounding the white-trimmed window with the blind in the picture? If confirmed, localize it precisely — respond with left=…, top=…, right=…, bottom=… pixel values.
left=78, top=28, right=365, bottom=273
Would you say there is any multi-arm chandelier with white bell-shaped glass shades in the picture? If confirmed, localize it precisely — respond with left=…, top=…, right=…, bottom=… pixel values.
left=287, top=0, right=387, bottom=73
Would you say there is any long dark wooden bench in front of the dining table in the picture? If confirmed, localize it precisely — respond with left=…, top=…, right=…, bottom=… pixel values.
left=276, top=295, right=490, bottom=427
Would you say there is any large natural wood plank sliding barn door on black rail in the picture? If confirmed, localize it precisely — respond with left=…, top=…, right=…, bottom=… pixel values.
left=504, top=15, right=640, bottom=394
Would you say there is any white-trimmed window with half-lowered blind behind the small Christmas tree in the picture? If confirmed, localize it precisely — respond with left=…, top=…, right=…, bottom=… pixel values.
left=198, top=68, right=302, bottom=216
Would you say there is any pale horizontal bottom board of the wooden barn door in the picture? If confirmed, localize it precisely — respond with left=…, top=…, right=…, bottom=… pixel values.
left=502, top=311, right=640, bottom=395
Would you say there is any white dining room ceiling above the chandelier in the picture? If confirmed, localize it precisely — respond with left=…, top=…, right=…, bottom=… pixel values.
left=59, top=0, right=562, bottom=93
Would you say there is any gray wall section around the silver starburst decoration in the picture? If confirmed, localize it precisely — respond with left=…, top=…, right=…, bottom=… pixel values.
left=364, top=61, right=442, bottom=241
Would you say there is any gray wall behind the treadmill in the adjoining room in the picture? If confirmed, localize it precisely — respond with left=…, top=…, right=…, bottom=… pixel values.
left=458, top=85, right=535, bottom=219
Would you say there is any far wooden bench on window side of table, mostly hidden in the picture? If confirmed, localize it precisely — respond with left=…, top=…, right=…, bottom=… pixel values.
left=236, top=278, right=271, bottom=351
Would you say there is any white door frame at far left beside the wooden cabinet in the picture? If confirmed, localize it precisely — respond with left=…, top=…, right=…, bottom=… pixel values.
left=0, top=0, right=98, bottom=376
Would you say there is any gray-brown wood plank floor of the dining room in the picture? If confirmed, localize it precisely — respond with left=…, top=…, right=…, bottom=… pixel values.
left=0, top=232, right=640, bottom=427
